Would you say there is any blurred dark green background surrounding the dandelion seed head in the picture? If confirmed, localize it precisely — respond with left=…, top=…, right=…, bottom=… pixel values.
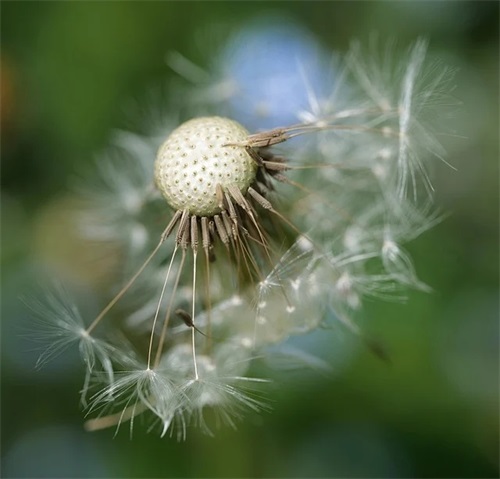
left=0, top=1, right=499, bottom=478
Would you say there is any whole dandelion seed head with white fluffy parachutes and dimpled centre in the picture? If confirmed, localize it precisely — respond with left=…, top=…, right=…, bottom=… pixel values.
left=30, top=29, right=449, bottom=438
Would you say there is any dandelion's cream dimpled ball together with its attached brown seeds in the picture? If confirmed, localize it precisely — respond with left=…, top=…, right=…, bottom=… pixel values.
left=155, top=117, right=296, bottom=274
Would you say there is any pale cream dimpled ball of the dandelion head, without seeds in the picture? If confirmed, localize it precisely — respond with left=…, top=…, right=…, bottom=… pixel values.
left=155, top=117, right=257, bottom=216
